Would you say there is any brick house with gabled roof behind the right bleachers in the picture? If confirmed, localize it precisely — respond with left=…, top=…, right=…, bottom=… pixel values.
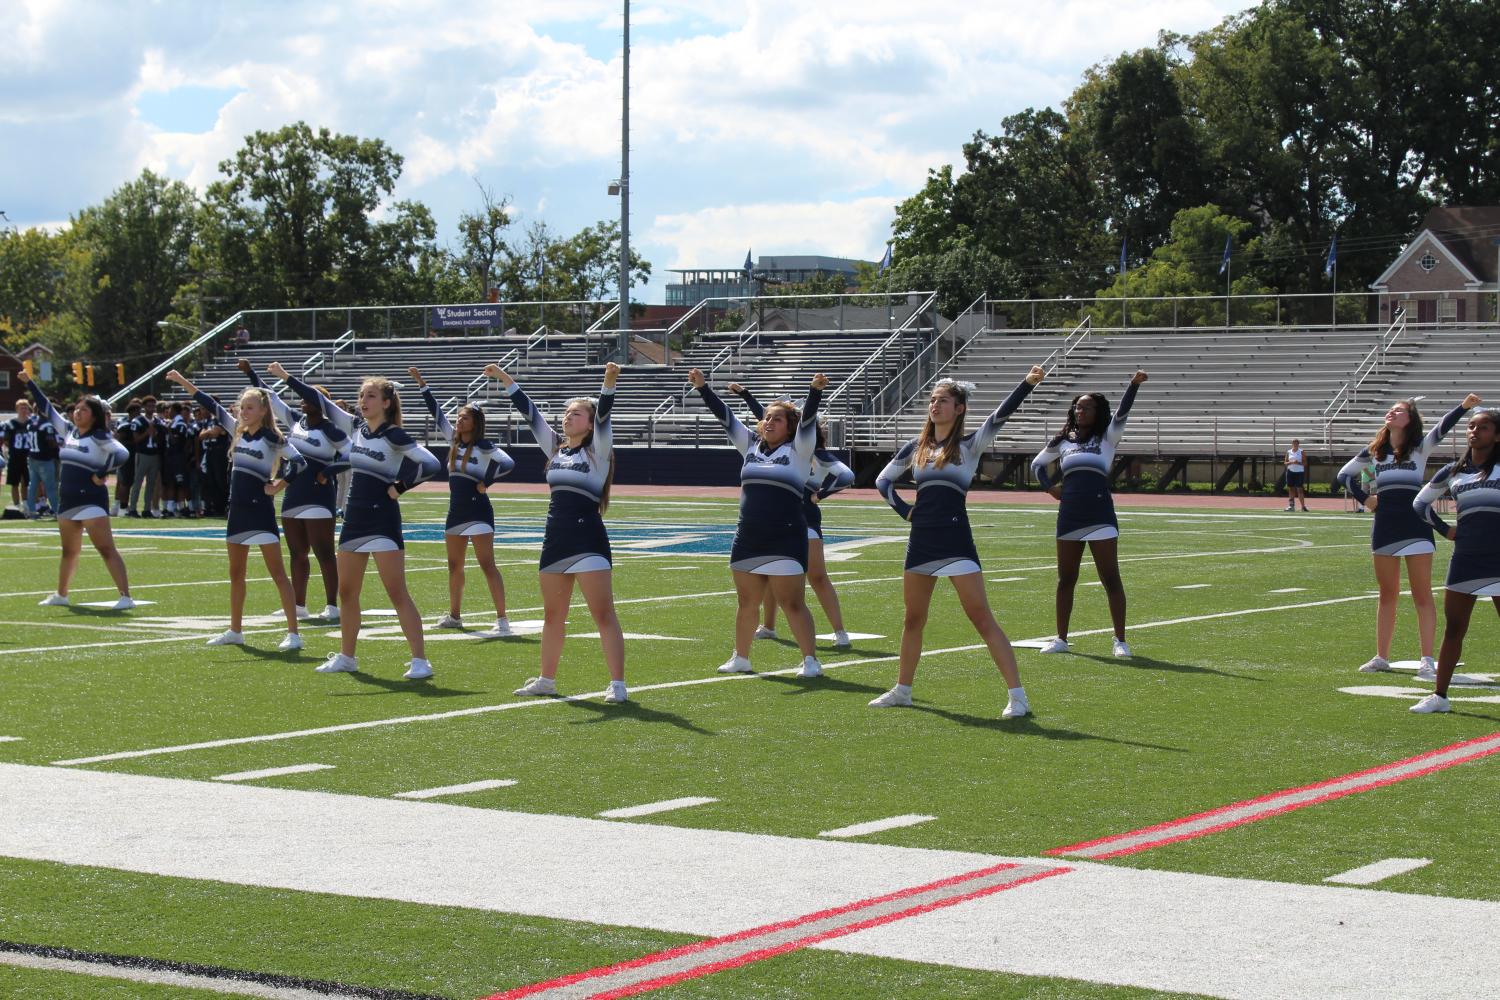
left=1370, top=205, right=1500, bottom=325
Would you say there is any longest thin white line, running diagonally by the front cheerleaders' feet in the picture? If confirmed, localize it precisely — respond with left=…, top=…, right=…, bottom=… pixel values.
left=53, top=595, right=1370, bottom=768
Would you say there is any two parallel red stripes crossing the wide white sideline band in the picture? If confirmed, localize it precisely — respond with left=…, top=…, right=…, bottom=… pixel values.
left=483, top=864, right=1071, bottom=1000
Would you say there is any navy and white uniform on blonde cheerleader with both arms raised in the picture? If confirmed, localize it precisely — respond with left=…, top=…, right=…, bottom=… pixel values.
left=506, top=382, right=615, bottom=573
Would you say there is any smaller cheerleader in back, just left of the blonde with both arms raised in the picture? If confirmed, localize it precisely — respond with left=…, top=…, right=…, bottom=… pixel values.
left=407, top=367, right=516, bottom=636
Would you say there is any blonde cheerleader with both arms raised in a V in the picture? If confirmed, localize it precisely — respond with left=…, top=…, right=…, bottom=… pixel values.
left=485, top=361, right=629, bottom=705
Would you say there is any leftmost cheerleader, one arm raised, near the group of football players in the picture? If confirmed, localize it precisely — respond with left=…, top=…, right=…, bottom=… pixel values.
left=17, top=369, right=135, bottom=612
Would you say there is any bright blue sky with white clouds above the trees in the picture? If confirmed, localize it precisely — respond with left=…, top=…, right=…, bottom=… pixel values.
left=0, top=0, right=1251, bottom=303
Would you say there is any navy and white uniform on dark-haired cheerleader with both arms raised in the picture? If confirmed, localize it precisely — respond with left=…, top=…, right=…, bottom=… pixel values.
left=698, top=382, right=822, bottom=576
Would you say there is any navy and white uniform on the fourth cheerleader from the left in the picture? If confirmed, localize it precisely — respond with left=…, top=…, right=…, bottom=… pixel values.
left=318, top=395, right=443, bottom=552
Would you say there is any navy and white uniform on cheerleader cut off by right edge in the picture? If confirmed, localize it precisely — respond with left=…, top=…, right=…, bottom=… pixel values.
left=1416, top=462, right=1500, bottom=597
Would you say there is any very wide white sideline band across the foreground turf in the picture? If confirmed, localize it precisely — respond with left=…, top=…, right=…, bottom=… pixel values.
left=0, top=765, right=1500, bottom=1000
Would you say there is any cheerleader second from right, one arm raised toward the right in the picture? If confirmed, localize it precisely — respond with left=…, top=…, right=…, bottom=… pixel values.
left=1338, top=393, right=1479, bottom=681
